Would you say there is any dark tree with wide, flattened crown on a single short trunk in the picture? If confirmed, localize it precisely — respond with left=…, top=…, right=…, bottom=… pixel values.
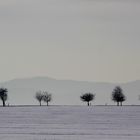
left=80, top=93, right=95, bottom=106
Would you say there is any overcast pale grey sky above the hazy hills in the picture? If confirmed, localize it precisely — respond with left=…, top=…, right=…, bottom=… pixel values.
left=0, top=0, right=140, bottom=82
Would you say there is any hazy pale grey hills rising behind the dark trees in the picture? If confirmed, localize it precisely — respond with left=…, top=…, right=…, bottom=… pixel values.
left=0, top=77, right=140, bottom=105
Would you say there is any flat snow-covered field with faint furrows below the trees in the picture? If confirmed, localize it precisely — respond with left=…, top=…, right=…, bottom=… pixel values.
left=0, top=106, right=140, bottom=140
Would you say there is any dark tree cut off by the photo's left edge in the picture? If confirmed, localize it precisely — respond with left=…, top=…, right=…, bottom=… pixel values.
left=0, top=88, right=8, bottom=106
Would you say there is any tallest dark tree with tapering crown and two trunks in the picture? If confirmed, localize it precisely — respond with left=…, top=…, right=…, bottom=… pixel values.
left=112, top=86, right=126, bottom=106
